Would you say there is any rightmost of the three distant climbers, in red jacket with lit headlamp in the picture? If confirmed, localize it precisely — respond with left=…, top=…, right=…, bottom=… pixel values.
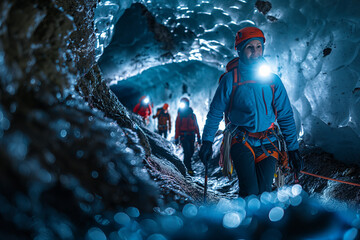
left=175, top=97, right=201, bottom=176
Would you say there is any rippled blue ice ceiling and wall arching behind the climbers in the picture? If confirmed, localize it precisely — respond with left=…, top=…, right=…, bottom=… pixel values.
left=95, top=0, right=360, bottom=163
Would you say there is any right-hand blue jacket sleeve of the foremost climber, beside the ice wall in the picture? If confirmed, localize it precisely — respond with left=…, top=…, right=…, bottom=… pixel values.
left=274, top=75, right=299, bottom=151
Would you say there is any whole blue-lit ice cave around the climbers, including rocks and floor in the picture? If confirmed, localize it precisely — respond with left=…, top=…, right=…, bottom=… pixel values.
left=0, top=0, right=360, bottom=240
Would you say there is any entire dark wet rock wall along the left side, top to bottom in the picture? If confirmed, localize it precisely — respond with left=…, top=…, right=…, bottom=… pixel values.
left=0, top=0, right=158, bottom=239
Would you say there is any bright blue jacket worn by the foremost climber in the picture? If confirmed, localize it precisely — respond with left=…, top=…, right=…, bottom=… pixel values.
left=202, top=60, right=299, bottom=151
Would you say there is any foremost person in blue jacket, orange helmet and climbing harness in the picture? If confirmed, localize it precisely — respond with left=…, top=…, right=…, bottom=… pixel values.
left=200, top=27, right=303, bottom=197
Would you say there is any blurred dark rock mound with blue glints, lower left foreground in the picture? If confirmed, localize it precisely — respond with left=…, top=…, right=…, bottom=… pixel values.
left=0, top=99, right=158, bottom=236
